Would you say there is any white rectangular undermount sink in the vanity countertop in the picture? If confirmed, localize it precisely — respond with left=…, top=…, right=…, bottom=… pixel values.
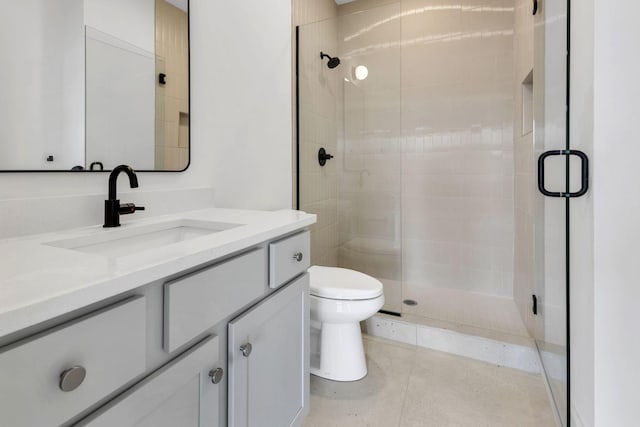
left=44, top=219, right=242, bottom=258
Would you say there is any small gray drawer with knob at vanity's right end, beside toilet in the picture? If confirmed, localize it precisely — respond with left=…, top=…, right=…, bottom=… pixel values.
left=269, top=231, right=311, bottom=288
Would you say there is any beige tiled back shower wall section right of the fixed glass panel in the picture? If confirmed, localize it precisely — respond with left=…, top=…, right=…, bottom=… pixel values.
left=402, top=0, right=514, bottom=300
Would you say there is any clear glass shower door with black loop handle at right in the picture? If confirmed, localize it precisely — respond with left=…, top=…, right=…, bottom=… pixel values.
left=533, top=0, right=588, bottom=426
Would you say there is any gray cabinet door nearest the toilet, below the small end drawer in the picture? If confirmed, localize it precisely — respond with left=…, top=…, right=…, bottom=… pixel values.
left=228, top=274, right=309, bottom=427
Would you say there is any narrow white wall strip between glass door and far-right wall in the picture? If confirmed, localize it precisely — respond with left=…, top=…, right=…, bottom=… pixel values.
left=570, top=0, right=596, bottom=426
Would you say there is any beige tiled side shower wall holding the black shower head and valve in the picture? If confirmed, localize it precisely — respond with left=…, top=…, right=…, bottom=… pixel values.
left=292, top=0, right=342, bottom=266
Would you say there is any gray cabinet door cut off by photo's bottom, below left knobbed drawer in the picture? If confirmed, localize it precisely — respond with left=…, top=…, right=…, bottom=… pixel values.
left=77, top=336, right=220, bottom=427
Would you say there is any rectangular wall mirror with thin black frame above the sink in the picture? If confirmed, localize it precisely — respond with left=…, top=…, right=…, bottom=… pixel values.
left=0, top=0, right=190, bottom=172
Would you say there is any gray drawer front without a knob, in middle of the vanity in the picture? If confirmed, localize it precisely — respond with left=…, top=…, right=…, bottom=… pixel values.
left=164, top=249, right=267, bottom=352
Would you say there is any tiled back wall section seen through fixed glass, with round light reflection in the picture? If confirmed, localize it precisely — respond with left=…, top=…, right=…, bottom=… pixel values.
left=338, top=3, right=402, bottom=314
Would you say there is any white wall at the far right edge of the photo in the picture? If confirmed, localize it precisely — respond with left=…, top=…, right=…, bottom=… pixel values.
left=593, top=0, right=640, bottom=426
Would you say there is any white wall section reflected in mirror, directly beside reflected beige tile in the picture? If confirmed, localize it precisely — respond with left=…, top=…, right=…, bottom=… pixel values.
left=84, top=0, right=156, bottom=170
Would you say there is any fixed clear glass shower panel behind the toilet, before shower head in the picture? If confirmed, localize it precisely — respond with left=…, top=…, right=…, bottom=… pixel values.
left=297, top=3, right=402, bottom=314
